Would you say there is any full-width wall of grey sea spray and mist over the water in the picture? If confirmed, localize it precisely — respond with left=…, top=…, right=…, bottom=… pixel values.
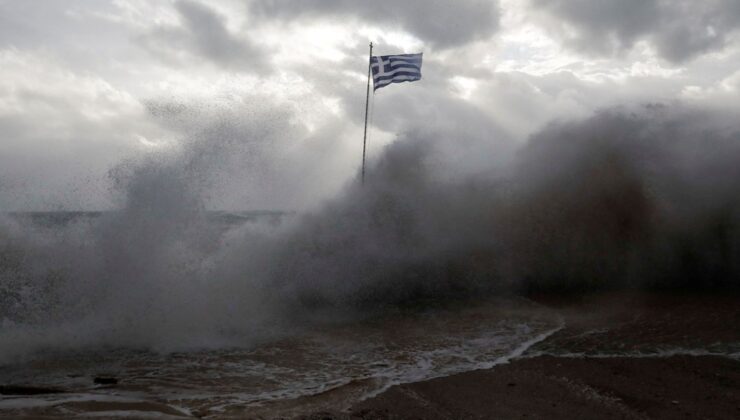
left=0, top=106, right=740, bottom=363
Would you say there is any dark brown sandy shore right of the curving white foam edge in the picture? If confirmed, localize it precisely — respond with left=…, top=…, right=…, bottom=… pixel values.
left=301, top=294, right=740, bottom=419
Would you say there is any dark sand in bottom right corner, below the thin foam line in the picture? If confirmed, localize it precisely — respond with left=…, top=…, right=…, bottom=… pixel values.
left=352, top=356, right=740, bottom=419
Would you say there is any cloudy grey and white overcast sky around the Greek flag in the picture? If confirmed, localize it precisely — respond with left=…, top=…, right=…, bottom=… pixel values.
left=0, top=0, right=740, bottom=210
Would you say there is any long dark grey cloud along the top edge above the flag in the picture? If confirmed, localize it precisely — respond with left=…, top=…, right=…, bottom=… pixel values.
left=252, top=0, right=499, bottom=48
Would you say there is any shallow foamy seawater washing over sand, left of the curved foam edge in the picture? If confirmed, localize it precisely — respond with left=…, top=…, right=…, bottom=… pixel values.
left=0, top=299, right=561, bottom=417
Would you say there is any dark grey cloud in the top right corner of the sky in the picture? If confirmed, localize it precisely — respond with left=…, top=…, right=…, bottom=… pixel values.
left=531, top=0, right=740, bottom=62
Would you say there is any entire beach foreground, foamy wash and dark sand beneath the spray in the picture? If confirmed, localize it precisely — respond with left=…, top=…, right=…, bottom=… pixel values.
left=0, top=291, right=740, bottom=420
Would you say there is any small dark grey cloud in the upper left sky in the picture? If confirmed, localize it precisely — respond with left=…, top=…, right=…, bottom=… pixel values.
left=141, top=0, right=268, bottom=72
